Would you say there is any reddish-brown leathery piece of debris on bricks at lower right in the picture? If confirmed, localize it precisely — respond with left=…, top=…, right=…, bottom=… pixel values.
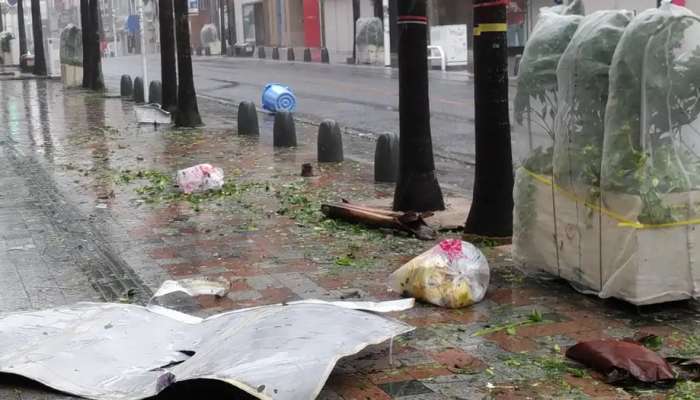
left=566, top=340, right=676, bottom=383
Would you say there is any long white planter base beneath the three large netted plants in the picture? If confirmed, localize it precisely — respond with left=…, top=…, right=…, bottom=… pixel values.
left=513, top=169, right=700, bottom=305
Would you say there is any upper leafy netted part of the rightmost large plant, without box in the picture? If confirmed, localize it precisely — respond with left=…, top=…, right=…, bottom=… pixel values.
left=602, top=4, right=700, bottom=224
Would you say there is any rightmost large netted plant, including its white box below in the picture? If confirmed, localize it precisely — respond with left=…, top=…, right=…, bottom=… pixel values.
left=599, top=3, right=700, bottom=304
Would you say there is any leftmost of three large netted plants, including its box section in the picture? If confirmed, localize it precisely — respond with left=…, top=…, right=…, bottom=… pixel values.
left=513, top=8, right=583, bottom=272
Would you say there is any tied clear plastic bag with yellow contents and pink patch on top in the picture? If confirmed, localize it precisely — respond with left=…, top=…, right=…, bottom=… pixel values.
left=389, top=239, right=489, bottom=308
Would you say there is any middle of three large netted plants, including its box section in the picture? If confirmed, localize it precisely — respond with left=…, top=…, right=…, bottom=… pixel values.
left=553, top=10, right=633, bottom=290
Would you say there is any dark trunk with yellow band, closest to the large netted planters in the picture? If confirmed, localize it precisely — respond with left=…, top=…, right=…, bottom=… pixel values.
left=465, top=0, right=513, bottom=238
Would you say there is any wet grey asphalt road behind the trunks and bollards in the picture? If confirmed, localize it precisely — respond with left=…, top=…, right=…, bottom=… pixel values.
left=103, top=55, right=536, bottom=167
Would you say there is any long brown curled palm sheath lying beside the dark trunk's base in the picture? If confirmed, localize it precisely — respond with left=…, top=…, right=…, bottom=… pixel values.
left=321, top=200, right=435, bottom=240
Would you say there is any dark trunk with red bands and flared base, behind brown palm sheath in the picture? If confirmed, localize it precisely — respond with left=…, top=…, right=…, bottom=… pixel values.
left=394, top=0, right=445, bottom=211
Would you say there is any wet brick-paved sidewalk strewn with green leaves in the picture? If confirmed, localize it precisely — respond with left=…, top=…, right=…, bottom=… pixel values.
left=0, top=81, right=700, bottom=400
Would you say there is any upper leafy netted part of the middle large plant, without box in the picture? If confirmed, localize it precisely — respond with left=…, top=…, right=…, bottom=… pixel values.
left=554, top=10, right=633, bottom=192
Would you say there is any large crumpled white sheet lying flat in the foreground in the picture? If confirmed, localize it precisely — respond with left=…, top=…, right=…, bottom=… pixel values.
left=0, top=300, right=413, bottom=400
